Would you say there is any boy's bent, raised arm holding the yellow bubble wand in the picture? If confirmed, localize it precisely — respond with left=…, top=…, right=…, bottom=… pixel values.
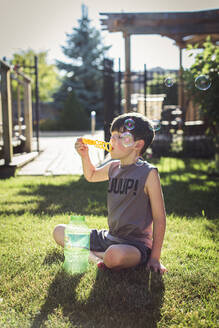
left=75, top=138, right=111, bottom=182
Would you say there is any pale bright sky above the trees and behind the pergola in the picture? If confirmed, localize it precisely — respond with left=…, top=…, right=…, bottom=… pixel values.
left=0, top=0, right=219, bottom=71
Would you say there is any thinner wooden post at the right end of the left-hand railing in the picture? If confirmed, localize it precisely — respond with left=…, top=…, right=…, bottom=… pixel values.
left=24, top=78, right=33, bottom=153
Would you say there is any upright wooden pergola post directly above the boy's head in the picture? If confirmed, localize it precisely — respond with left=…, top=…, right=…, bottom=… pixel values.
left=123, top=33, right=131, bottom=113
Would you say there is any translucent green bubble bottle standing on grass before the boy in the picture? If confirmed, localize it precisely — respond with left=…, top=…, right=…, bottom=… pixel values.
left=63, top=216, right=90, bottom=274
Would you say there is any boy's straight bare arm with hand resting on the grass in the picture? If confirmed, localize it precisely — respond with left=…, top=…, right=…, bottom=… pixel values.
left=145, top=170, right=167, bottom=274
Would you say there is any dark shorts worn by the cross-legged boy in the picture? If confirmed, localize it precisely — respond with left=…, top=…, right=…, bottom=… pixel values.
left=90, top=229, right=151, bottom=264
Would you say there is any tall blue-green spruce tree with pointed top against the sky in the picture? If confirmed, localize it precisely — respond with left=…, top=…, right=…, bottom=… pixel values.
left=55, top=5, right=109, bottom=126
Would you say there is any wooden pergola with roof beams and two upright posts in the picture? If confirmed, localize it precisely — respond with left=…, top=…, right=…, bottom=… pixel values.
left=100, top=9, right=219, bottom=112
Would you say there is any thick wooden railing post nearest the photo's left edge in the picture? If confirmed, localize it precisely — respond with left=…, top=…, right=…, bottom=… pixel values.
left=0, top=61, right=13, bottom=165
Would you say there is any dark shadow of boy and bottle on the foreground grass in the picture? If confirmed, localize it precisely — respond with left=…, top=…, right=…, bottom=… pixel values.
left=31, top=256, right=165, bottom=328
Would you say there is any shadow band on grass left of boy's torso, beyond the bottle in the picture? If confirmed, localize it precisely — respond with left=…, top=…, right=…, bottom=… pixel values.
left=15, top=176, right=107, bottom=216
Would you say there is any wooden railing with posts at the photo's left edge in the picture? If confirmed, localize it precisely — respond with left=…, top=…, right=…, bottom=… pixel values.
left=0, top=60, right=32, bottom=165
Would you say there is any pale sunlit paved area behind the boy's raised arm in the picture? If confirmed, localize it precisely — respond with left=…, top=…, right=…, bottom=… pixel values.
left=18, top=131, right=104, bottom=175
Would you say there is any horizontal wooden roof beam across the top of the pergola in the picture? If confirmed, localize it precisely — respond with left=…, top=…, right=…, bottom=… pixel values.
left=100, top=9, right=219, bottom=36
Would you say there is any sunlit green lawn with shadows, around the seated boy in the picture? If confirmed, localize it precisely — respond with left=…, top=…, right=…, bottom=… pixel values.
left=0, top=158, right=219, bottom=328
